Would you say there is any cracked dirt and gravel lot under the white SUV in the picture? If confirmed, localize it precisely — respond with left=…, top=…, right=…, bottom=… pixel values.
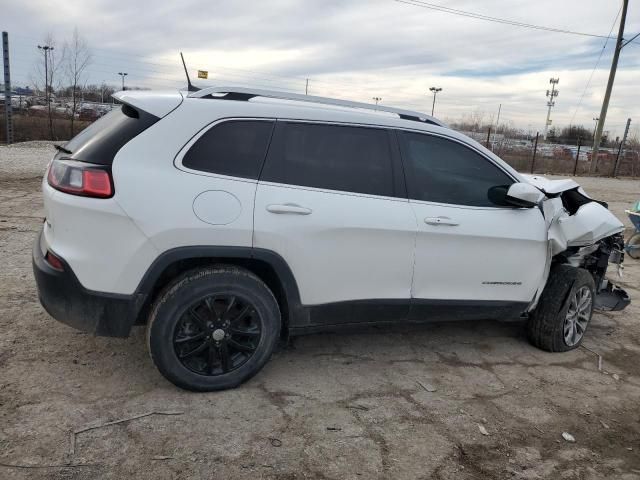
left=0, top=143, right=640, bottom=479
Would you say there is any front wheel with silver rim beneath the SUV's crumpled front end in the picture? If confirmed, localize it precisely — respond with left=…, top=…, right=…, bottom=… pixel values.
left=527, top=265, right=595, bottom=352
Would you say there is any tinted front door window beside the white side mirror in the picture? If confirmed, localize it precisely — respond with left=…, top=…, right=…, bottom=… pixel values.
left=399, top=132, right=513, bottom=207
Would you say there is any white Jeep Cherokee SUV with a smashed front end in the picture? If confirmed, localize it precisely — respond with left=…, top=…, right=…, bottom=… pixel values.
left=33, top=87, right=629, bottom=390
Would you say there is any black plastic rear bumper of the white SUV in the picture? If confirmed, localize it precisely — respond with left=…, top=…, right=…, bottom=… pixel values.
left=33, top=232, right=139, bottom=337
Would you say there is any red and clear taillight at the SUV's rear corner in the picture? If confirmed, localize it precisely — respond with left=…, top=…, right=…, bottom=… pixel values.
left=47, top=160, right=113, bottom=198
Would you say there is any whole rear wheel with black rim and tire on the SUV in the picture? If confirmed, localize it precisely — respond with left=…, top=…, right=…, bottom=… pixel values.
left=147, top=266, right=281, bottom=391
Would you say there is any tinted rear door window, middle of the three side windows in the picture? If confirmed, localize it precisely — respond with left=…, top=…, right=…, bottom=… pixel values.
left=262, top=122, right=394, bottom=196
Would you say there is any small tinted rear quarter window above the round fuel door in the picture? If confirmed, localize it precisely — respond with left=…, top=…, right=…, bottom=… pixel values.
left=182, top=120, right=274, bottom=180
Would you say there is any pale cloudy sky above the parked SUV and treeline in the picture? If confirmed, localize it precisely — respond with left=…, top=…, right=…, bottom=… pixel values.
left=5, top=0, right=640, bottom=139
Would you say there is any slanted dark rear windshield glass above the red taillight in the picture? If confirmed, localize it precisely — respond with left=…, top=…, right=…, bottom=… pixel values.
left=60, top=105, right=160, bottom=165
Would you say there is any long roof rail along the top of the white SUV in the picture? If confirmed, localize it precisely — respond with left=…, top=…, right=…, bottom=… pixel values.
left=188, top=87, right=446, bottom=127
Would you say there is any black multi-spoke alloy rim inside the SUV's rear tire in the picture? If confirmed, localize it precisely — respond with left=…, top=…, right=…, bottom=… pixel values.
left=173, top=293, right=262, bottom=376
